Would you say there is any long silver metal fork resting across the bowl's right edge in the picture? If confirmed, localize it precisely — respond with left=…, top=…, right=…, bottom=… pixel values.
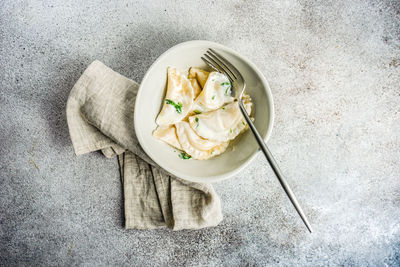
left=201, top=48, right=312, bottom=233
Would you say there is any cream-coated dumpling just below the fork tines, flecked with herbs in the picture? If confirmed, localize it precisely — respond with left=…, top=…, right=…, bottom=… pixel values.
left=193, top=72, right=234, bottom=113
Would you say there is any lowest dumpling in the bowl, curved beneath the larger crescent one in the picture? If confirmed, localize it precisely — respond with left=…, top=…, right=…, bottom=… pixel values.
left=175, top=121, right=229, bottom=160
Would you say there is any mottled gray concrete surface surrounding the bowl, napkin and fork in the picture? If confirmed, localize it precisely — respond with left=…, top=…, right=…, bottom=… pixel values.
left=0, top=0, right=400, bottom=266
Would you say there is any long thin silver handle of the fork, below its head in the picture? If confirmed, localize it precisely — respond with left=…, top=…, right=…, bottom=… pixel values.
left=239, top=100, right=312, bottom=233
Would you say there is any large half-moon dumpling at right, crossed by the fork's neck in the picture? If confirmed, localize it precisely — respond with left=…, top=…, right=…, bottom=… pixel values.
left=189, top=95, right=252, bottom=142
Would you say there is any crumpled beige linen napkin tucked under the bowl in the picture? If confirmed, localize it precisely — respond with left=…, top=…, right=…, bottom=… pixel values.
left=67, top=60, right=222, bottom=230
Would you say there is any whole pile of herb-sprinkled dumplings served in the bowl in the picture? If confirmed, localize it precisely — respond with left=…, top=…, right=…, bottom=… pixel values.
left=153, top=68, right=252, bottom=160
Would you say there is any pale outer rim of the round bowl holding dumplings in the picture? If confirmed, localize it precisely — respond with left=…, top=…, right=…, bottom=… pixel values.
left=134, top=40, right=275, bottom=183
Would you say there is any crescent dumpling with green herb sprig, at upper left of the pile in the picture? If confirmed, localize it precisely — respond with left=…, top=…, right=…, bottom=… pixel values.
left=156, top=67, right=194, bottom=125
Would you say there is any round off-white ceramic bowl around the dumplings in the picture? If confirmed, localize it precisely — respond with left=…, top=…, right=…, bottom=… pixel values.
left=134, top=41, right=274, bottom=183
